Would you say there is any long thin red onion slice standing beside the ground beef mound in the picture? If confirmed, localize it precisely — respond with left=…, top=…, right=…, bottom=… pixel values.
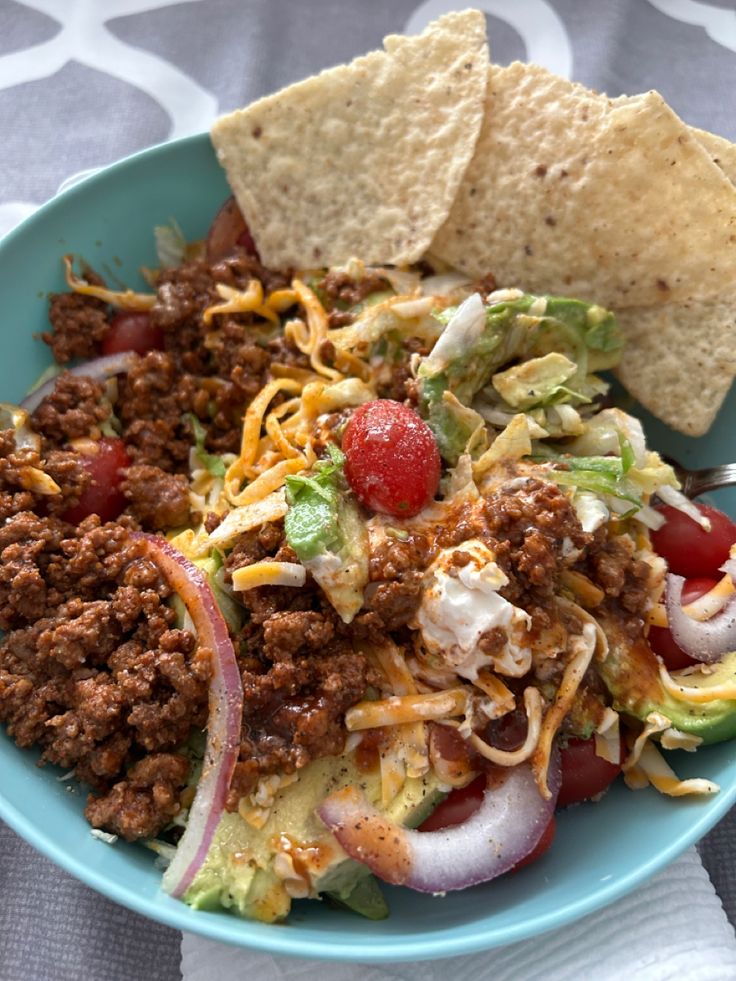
left=134, top=534, right=243, bottom=896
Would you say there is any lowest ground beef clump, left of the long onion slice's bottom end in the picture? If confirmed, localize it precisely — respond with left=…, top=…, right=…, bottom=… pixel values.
left=84, top=753, right=189, bottom=841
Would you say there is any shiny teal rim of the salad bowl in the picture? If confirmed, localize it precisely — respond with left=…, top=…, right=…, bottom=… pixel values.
left=0, top=133, right=736, bottom=964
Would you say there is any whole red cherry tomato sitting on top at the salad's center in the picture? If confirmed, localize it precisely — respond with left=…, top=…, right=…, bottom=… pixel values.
left=342, top=399, right=440, bottom=518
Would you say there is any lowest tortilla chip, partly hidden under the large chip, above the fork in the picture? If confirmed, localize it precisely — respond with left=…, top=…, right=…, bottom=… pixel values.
left=616, top=286, right=736, bottom=436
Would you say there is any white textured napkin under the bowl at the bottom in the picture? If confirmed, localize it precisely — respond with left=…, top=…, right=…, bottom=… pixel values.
left=181, top=848, right=736, bottom=981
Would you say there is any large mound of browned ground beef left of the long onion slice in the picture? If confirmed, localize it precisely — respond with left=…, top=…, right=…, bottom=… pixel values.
left=0, top=511, right=210, bottom=837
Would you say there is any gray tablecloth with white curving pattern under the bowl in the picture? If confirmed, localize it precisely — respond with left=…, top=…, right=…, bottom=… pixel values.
left=0, top=0, right=736, bottom=981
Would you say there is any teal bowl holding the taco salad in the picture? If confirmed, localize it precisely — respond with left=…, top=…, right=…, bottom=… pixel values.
left=0, top=136, right=736, bottom=962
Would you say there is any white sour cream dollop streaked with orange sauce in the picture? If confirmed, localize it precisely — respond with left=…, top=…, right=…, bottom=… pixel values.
left=412, top=539, right=532, bottom=681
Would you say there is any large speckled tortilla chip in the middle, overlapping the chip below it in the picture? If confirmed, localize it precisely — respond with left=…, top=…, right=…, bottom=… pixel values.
left=431, top=63, right=736, bottom=309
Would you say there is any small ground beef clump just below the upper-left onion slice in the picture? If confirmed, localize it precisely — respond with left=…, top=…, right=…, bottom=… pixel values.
left=31, top=371, right=110, bottom=447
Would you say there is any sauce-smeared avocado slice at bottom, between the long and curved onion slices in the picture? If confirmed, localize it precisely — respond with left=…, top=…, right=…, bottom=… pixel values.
left=184, top=755, right=444, bottom=922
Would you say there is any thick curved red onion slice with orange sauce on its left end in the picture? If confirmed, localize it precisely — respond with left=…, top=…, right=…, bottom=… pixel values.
left=317, top=754, right=560, bottom=893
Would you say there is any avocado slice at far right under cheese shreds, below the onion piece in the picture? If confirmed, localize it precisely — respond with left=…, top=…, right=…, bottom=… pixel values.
left=599, top=621, right=736, bottom=745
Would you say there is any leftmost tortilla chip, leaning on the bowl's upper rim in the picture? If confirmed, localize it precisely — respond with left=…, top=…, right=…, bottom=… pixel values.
left=212, top=10, right=488, bottom=269
